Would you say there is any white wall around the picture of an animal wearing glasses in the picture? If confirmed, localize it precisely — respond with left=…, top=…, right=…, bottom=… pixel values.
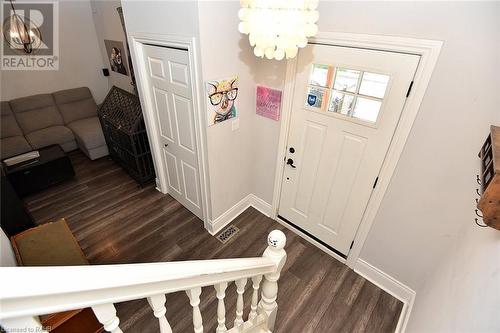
left=198, top=1, right=258, bottom=219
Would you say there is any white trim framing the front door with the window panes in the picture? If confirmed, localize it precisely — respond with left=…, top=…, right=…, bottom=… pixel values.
left=271, top=32, right=443, bottom=268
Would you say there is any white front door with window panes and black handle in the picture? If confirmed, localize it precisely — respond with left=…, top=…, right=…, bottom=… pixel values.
left=278, top=44, right=420, bottom=256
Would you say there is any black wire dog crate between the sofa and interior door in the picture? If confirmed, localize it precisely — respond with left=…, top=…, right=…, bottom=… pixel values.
left=98, top=86, right=155, bottom=186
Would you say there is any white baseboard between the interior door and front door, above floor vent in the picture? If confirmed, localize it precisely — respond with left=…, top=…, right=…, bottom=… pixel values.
left=207, top=193, right=271, bottom=236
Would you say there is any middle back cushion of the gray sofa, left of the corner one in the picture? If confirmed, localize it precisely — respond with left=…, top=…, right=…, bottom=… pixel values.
left=10, top=94, right=63, bottom=134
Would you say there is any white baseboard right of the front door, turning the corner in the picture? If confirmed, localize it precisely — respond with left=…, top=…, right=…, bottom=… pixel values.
left=354, top=258, right=416, bottom=333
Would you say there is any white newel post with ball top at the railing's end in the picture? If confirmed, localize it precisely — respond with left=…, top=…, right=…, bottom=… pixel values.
left=258, top=230, right=286, bottom=331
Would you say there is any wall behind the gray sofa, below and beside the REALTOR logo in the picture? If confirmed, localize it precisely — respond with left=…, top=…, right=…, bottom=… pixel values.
left=1, top=0, right=108, bottom=103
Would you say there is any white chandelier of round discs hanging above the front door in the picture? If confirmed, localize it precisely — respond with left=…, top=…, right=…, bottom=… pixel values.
left=238, top=0, right=319, bottom=60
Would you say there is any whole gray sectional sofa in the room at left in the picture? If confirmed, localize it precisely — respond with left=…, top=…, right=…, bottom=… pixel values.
left=0, top=87, right=108, bottom=160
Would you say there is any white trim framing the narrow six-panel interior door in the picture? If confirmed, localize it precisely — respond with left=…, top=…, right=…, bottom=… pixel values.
left=129, top=33, right=211, bottom=228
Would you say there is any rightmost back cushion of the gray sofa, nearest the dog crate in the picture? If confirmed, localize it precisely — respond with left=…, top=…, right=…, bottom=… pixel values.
left=53, top=87, right=97, bottom=124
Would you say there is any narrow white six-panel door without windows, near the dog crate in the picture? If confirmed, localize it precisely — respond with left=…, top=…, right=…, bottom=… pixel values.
left=143, top=45, right=203, bottom=219
